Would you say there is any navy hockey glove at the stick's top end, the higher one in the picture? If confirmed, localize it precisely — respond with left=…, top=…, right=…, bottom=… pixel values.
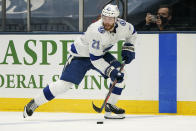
left=122, top=43, right=135, bottom=64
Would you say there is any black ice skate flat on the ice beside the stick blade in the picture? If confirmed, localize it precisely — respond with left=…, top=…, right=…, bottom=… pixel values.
left=104, top=103, right=125, bottom=119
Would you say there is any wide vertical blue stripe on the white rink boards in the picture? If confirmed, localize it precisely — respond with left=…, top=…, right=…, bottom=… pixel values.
left=159, top=33, right=177, bottom=113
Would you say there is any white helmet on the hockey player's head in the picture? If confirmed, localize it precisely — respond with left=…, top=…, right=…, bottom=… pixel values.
left=101, top=4, right=120, bottom=18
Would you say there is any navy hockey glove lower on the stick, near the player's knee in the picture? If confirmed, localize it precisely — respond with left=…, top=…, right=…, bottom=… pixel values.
left=106, top=67, right=124, bottom=83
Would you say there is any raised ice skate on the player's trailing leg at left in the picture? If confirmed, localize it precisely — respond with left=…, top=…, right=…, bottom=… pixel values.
left=23, top=99, right=38, bottom=118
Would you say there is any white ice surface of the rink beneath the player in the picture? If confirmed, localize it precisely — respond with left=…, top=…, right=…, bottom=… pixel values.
left=0, top=112, right=196, bottom=131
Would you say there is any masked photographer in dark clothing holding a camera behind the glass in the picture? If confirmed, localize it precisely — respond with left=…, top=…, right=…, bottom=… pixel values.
left=143, top=5, right=175, bottom=31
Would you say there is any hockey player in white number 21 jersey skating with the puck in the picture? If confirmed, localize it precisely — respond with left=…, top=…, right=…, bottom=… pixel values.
left=23, top=4, right=137, bottom=119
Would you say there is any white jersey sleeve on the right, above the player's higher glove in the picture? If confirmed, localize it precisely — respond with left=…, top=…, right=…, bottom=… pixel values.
left=125, top=23, right=137, bottom=45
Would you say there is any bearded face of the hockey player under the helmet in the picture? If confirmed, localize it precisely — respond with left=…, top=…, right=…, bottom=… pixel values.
left=102, top=16, right=115, bottom=31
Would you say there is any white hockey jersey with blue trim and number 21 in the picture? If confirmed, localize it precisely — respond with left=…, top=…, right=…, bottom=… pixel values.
left=70, top=18, right=137, bottom=74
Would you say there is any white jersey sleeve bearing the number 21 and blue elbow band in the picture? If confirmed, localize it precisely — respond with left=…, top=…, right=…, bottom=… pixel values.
left=86, top=26, right=110, bottom=77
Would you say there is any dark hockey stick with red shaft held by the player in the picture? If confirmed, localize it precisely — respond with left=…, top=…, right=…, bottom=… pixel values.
left=92, top=62, right=125, bottom=113
